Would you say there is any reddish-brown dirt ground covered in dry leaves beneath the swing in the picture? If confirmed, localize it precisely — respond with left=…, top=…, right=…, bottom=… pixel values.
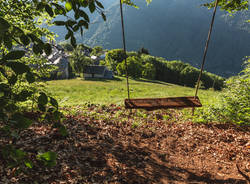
left=0, top=106, right=250, bottom=184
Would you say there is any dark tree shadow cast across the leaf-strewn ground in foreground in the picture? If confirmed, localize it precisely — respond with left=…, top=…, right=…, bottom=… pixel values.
left=4, top=113, right=247, bottom=184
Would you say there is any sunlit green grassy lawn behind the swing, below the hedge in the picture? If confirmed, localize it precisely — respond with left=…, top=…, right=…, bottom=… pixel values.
left=48, top=77, right=219, bottom=106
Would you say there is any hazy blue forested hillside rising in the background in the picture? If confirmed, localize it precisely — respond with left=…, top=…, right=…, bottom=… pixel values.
left=50, top=0, right=250, bottom=76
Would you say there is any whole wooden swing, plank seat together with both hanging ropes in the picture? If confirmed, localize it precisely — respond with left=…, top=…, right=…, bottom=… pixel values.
left=120, top=0, right=219, bottom=109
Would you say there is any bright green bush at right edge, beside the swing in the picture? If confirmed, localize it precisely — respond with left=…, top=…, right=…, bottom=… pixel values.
left=195, top=59, right=250, bottom=125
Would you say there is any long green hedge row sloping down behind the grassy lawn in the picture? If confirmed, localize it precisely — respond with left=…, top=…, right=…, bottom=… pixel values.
left=104, top=49, right=225, bottom=90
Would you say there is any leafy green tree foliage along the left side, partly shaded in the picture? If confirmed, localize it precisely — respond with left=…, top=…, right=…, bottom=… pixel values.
left=0, top=0, right=106, bottom=174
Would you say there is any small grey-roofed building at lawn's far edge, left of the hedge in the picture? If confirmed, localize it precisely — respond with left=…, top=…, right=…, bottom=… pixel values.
left=83, top=65, right=113, bottom=79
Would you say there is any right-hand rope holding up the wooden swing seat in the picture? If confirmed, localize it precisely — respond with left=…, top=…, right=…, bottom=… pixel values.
left=194, top=0, right=219, bottom=97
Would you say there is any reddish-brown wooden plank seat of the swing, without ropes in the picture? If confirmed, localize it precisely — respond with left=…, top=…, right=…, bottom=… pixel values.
left=125, top=96, right=202, bottom=110
